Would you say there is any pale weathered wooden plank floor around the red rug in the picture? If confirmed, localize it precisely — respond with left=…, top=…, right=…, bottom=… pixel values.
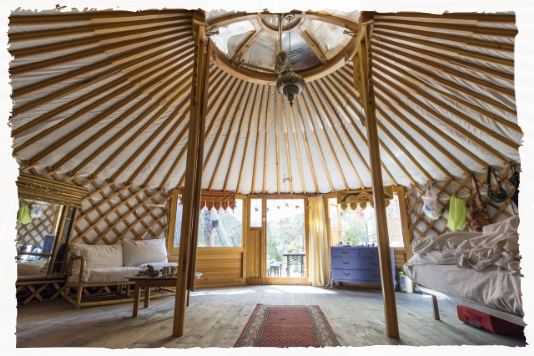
left=0, top=286, right=534, bottom=356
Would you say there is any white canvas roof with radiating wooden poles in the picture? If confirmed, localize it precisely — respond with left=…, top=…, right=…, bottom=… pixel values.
left=0, top=0, right=534, bottom=194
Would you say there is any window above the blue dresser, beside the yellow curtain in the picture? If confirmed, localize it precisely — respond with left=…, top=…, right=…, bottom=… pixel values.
left=329, top=194, right=404, bottom=247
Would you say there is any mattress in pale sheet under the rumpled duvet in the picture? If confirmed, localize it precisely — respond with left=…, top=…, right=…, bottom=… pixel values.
left=404, top=265, right=534, bottom=319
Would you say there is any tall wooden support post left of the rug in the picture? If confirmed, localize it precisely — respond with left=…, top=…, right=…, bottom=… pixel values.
left=173, top=25, right=209, bottom=336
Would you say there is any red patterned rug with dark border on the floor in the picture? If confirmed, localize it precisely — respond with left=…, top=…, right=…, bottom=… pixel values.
left=230, top=304, right=345, bottom=356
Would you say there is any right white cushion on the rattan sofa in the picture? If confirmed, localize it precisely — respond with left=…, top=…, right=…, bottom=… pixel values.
left=121, top=239, right=169, bottom=267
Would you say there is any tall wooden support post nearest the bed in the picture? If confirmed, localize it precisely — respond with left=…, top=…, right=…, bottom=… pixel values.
left=354, top=23, right=399, bottom=338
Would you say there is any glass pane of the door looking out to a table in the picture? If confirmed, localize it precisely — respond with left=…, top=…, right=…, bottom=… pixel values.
left=266, top=199, right=307, bottom=278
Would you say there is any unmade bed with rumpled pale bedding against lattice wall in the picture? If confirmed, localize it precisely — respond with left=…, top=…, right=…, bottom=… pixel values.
left=403, top=214, right=534, bottom=330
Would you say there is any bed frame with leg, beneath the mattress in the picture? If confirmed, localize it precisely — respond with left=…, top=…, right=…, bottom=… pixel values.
left=416, top=284, right=534, bottom=330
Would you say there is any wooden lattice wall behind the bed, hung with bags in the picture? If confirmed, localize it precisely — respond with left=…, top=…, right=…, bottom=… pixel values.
left=407, top=160, right=534, bottom=238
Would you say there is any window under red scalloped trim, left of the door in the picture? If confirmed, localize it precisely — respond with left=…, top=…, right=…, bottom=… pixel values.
left=174, top=199, right=243, bottom=247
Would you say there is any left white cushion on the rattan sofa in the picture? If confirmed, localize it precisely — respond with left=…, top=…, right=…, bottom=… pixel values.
left=70, top=244, right=124, bottom=275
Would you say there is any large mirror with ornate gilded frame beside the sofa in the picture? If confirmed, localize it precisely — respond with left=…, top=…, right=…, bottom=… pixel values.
left=0, top=168, right=87, bottom=283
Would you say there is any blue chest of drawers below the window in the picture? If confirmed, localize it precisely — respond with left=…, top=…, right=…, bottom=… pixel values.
left=330, top=246, right=397, bottom=288
